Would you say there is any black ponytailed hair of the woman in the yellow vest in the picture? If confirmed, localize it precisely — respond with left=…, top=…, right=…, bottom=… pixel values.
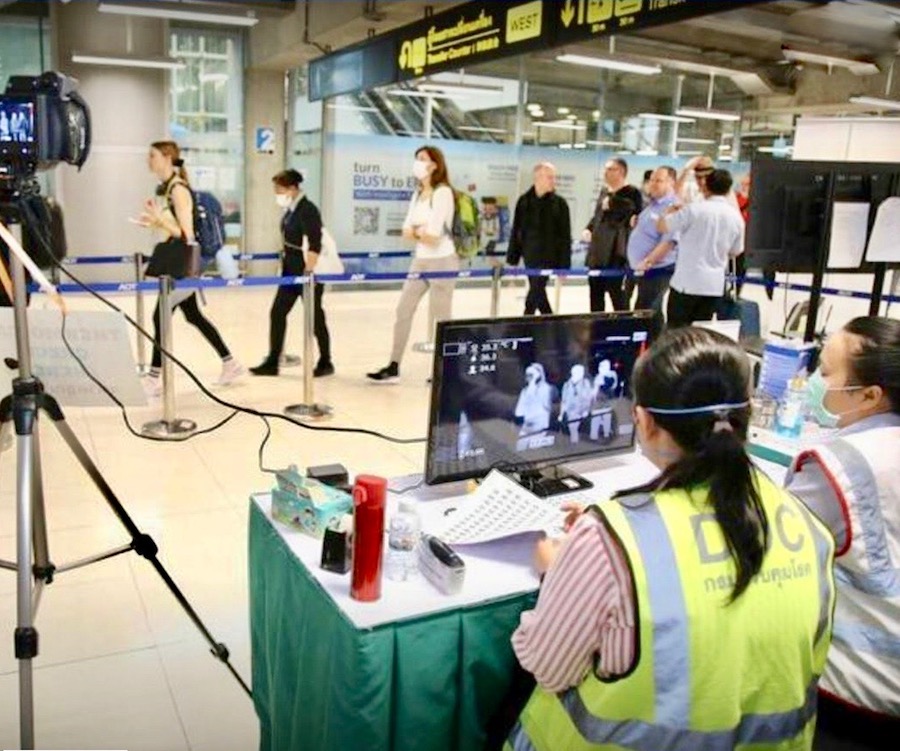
left=619, top=328, right=769, bottom=602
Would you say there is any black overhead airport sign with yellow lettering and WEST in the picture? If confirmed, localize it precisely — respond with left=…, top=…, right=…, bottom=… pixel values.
left=309, top=0, right=763, bottom=101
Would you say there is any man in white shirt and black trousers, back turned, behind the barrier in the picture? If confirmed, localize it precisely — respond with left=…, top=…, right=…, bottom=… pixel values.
left=657, top=170, right=744, bottom=326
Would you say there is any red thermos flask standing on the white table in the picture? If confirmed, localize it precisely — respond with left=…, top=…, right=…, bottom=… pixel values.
left=350, top=475, right=387, bottom=602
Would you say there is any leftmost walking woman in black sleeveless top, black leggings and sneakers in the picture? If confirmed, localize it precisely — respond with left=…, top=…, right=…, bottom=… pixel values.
left=140, top=141, right=245, bottom=396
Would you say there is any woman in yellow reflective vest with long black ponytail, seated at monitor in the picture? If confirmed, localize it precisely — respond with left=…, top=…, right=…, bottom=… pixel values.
left=505, top=328, right=834, bottom=751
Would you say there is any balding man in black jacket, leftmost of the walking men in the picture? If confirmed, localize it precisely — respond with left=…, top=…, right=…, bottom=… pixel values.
left=506, top=162, right=572, bottom=315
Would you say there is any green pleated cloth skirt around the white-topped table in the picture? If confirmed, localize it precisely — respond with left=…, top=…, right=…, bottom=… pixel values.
left=249, top=501, right=535, bottom=751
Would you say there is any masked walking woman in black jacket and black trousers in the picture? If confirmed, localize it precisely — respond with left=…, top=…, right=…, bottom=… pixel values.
left=250, top=169, right=334, bottom=378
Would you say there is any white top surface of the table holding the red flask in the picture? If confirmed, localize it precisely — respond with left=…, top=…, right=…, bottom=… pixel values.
left=252, top=453, right=657, bottom=629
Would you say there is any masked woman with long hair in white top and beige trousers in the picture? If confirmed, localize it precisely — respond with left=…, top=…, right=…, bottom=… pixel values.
left=368, top=146, right=459, bottom=383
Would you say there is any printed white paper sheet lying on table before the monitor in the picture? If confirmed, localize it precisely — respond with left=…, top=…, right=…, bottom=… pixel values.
left=438, top=470, right=566, bottom=545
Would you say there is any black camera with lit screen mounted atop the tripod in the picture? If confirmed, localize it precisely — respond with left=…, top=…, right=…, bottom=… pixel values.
left=0, top=71, right=91, bottom=182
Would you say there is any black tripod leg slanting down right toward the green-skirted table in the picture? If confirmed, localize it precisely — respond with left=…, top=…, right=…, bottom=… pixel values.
left=40, top=394, right=252, bottom=697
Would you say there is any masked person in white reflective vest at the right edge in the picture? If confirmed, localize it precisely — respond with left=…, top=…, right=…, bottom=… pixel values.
left=785, top=316, right=900, bottom=749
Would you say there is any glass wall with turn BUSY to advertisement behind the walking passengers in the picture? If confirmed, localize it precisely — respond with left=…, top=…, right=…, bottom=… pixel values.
left=310, top=39, right=748, bottom=266
